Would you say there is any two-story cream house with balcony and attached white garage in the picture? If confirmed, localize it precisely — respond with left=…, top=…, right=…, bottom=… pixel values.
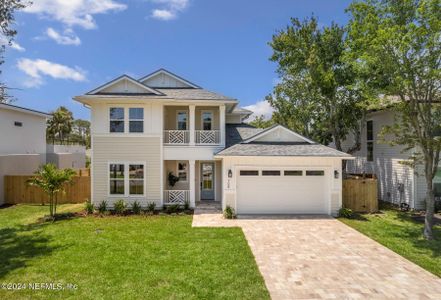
left=74, top=69, right=351, bottom=214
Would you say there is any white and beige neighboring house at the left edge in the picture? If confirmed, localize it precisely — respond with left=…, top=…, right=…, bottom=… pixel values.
left=0, top=103, right=51, bottom=205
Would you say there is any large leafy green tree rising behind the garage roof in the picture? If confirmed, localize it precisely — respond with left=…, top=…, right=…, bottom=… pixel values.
left=267, top=17, right=366, bottom=153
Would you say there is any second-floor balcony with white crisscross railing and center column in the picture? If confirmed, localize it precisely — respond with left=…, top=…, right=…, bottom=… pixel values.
left=163, top=105, right=225, bottom=145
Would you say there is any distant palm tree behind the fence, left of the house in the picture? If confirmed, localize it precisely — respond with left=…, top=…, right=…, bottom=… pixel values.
left=46, top=106, right=73, bottom=144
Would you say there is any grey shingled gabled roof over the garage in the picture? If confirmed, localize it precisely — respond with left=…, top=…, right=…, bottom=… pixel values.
left=215, top=124, right=352, bottom=159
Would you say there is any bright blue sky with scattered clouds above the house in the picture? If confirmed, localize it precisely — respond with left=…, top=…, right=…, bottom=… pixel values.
left=1, top=0, right=350, bottom=119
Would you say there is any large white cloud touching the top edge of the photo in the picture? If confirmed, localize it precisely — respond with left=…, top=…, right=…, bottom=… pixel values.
left=23, top=0, right=127, bottom=29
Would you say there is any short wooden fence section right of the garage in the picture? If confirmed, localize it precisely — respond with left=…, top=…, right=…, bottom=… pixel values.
left=343, top=178, right=378, bottom=213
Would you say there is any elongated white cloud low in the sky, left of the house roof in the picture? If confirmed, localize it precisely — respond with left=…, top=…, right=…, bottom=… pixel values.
left=17, top=58, right=86, bottom=87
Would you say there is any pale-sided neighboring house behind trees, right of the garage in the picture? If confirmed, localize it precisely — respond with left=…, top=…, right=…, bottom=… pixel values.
left=336, top=109, right=441, bottom=209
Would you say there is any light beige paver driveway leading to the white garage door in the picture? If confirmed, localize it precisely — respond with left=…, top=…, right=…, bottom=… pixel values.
left=193, top=214, right=441, bottom=299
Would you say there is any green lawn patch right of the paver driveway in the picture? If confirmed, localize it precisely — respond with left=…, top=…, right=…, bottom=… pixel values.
left=339, top=209, right=441, bottom=277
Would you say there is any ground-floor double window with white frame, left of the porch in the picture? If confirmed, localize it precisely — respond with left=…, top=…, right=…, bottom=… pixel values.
left=109, top=163, right=145, bottom=196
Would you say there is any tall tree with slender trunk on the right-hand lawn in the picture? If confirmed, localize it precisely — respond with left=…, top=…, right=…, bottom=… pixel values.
left=348, top=0, right=441, bottom=239
